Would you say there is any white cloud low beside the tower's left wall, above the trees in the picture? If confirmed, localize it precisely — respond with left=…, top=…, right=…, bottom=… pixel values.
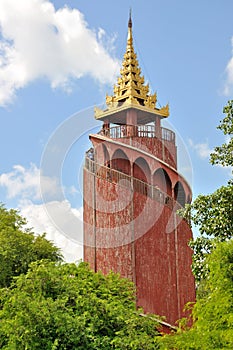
left=0, top=164, right=83, bottom=262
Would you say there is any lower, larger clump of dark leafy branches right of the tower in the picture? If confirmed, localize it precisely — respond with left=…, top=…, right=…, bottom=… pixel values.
left=185, top=184, right=233, bottom=283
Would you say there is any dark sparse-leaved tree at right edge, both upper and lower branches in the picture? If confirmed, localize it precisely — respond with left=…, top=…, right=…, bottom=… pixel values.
left=181, top=100, right=233, bottom=285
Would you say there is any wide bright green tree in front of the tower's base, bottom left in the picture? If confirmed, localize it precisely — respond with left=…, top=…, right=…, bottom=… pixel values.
left=0, top=260, right=158, bottom=350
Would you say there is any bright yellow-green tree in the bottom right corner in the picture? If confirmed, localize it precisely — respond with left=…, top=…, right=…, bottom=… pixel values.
left=162, top=240, right=233, bottom=350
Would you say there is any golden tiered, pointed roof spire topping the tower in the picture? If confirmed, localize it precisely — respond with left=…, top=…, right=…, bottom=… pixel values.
left=95, top=11, right=169, bottom=119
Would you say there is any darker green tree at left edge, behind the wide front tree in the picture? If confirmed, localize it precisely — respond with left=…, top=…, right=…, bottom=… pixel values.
left=0, top=205, right=62, bottom=288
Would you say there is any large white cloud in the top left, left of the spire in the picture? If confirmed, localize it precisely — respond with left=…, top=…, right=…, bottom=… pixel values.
left=0, top=0, right=119, bottom=105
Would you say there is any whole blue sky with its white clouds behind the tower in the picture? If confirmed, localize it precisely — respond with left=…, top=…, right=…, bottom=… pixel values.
left=0, top=0, right=233, bottom=260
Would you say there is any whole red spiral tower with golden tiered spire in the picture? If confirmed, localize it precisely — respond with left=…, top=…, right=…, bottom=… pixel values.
left=83, top=16, right=195, bottom=325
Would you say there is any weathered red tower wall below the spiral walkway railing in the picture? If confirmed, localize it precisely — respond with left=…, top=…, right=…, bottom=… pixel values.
left=84, top=170, right=195, bottom=325
